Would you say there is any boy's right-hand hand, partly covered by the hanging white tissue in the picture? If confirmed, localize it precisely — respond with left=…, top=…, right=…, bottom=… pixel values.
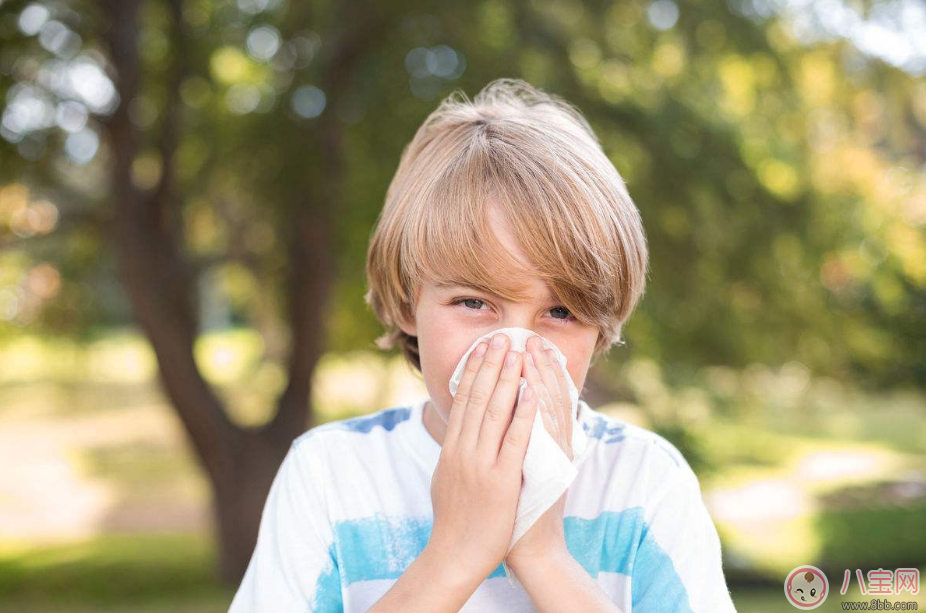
left=505, top=336, right=574, bottom=572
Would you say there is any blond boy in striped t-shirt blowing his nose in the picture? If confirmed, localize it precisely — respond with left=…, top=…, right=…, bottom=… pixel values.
left=230, top=79, right=735, bottom=613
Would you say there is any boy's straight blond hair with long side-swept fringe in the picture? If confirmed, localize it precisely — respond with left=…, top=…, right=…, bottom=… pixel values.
left=364, top=78, right=648, bottom=371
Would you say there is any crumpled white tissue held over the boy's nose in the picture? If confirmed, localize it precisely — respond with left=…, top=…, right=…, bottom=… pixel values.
left=450, top=328, right=587, bottom=587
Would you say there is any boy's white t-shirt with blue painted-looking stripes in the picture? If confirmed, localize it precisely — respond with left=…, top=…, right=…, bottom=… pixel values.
left=229, top=397, right=735, bottom=613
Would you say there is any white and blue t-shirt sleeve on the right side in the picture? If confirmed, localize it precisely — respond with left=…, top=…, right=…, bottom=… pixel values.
left=631, top=465, right=736, bottom=613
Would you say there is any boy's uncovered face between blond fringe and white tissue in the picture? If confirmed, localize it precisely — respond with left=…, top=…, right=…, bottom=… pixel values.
left=403, top=203, right=598, bottom=422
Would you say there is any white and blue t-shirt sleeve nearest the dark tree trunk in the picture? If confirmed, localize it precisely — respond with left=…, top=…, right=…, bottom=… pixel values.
left=229, top=435, right=343, bottom=613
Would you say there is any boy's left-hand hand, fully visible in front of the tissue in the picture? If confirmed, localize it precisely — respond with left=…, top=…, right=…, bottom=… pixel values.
left=427, top=334, right=538, bottom=583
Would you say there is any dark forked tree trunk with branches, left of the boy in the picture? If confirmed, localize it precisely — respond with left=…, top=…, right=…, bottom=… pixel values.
left=90, top=0, right=398, bottom=582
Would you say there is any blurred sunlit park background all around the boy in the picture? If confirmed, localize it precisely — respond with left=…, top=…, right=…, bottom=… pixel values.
left=0, top=0, right=926, bottom=613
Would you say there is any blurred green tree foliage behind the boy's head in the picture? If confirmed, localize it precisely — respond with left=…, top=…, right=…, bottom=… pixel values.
left=0, top=0, right=926, bottom=386
